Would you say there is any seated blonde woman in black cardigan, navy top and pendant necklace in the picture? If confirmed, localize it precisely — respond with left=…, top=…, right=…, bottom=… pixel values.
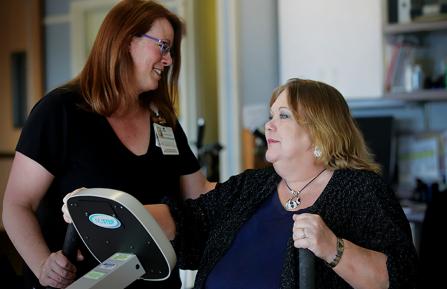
left=65, top=79, right=417, bottom=289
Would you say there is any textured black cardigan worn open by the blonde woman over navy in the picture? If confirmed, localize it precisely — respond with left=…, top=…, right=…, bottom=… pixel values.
left=171, top=168, right=417, bottom=289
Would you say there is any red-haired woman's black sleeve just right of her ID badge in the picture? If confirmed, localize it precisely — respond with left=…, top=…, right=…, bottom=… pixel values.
left=175, top=121, right=200, bottom=175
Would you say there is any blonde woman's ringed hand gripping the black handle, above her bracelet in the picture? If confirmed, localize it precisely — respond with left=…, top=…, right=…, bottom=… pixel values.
left=293, top=213, right=337, bottom=262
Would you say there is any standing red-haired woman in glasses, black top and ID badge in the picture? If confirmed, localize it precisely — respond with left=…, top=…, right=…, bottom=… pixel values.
left=3, top=0, right=214, bottom=288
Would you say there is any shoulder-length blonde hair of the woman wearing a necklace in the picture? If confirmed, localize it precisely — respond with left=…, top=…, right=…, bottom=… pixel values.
left=270, top=78, right=381, bottom=173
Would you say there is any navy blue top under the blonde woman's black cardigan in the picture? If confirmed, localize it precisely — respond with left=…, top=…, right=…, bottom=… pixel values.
left=206, top=193, right=295, bottom=289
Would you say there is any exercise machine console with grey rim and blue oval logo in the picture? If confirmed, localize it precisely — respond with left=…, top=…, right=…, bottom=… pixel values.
left=63, top=188, right=176, bottom=289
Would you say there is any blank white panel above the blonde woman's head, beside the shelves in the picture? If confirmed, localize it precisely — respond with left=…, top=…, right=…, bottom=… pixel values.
left=278, top=0, right=384, bottom=98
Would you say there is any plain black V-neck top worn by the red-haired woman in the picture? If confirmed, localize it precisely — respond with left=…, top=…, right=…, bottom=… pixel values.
left=16, top=89, right=199, bottom=288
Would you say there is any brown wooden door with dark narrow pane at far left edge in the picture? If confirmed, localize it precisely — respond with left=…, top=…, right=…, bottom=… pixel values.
left=0, top=0, right=43, bottom=153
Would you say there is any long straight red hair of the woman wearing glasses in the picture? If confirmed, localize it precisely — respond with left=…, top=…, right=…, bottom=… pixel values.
left=69, top=0, right=183, bottom=125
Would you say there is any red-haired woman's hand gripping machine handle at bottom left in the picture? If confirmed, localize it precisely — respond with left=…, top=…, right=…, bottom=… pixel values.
left=38, top=251, right=76, bottom=288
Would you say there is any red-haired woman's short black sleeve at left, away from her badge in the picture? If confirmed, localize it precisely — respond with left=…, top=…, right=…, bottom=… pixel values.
left=16, top=91, right=67, bottom=175
